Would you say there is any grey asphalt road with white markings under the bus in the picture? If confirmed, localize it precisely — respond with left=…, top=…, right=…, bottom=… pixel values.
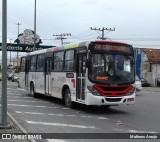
left=0, top=82, right=160, bottom=142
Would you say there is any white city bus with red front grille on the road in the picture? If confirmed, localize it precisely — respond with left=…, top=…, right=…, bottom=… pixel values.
left=19, top=40, right=135, bottom=107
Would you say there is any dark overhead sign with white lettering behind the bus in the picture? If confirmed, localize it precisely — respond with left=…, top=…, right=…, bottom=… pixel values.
left=0, top=43, right=54, bottom=52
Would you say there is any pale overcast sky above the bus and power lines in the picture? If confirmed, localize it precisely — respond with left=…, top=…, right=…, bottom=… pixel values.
left=0, top=0, right=160, bottom=59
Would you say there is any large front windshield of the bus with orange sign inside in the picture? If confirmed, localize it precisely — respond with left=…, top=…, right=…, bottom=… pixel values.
left=88, top=54, right=135, bottom=85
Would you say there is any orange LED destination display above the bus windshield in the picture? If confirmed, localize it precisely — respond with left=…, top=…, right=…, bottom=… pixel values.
left=95, top=44, right=126, bottom=51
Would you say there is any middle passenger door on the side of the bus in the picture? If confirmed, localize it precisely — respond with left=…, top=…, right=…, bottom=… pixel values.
left=45, top=58, right=52, bottom=95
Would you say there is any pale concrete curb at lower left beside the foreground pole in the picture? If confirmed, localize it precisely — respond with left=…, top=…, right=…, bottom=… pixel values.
left=7, top=111, right=36, bottom=142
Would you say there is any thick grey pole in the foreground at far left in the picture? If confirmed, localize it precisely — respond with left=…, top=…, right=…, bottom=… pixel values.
left=0, top=0, right=10, bottom=129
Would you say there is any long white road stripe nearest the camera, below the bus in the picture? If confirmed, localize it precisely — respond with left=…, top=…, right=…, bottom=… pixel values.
left=26, top=121, right=96, bottom=129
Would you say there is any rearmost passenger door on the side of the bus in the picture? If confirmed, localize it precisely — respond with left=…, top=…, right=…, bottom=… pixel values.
left=25, top=60, right=30, bottom=90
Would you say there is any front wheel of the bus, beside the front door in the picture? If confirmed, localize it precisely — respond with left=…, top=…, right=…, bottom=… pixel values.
left=64, top=89, right=73, bottom=108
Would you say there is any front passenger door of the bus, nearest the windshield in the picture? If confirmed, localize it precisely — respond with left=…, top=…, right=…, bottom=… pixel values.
left=76, top=54, right=86, bottom=101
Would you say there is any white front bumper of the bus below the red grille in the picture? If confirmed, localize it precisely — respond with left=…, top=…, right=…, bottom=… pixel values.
left=86, top=93, right=135, bottom=105
